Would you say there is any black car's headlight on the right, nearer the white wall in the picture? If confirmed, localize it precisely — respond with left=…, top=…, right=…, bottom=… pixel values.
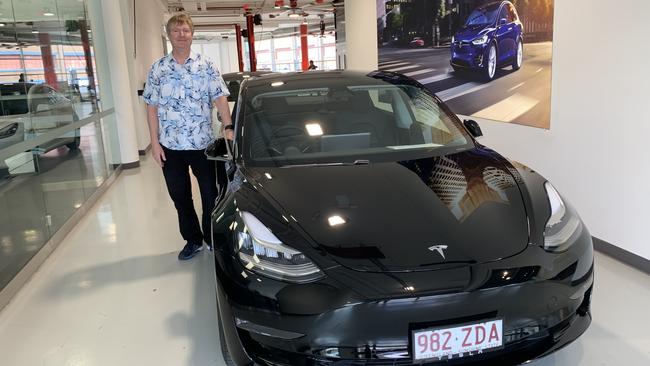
left=544, top=182, right=582, bottom=252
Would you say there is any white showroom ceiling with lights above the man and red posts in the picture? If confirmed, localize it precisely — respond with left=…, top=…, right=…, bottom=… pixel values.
left=163, top=0, right=343, bottom=40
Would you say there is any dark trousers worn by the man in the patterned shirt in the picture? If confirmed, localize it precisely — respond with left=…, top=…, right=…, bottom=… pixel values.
left=162, top=146, right=218, bottom=244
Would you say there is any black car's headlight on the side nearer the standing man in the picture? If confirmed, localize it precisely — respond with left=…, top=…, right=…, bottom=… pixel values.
left=237, top=212, right=324, bottom=283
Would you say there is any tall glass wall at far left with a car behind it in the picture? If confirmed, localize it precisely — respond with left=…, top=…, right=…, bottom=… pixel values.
left=0, top=0, right=114, bottom=289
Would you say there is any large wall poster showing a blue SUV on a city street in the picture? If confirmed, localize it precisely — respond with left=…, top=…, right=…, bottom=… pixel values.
left=377, top=0, right=553, bottom=129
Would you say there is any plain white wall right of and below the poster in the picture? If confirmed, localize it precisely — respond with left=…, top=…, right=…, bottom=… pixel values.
left=470, top=0, right=650, bottom=259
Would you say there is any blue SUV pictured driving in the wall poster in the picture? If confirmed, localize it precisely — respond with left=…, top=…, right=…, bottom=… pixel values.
left=451, top=1, right=523, bottom=81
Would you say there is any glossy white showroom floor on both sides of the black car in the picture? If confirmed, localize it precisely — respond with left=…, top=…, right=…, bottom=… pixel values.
left=0, top=158, right=650, bottom=366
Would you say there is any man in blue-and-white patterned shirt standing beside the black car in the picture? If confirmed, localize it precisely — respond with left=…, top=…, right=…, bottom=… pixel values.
left=143, top=14, right=233, bottom=260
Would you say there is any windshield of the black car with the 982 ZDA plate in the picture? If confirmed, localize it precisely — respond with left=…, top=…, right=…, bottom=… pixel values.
left=242, top=83, right=470, bottom=166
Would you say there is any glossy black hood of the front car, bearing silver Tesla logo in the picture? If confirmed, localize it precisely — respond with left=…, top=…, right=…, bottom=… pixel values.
left=246, top=149, right=529, bottom=271
